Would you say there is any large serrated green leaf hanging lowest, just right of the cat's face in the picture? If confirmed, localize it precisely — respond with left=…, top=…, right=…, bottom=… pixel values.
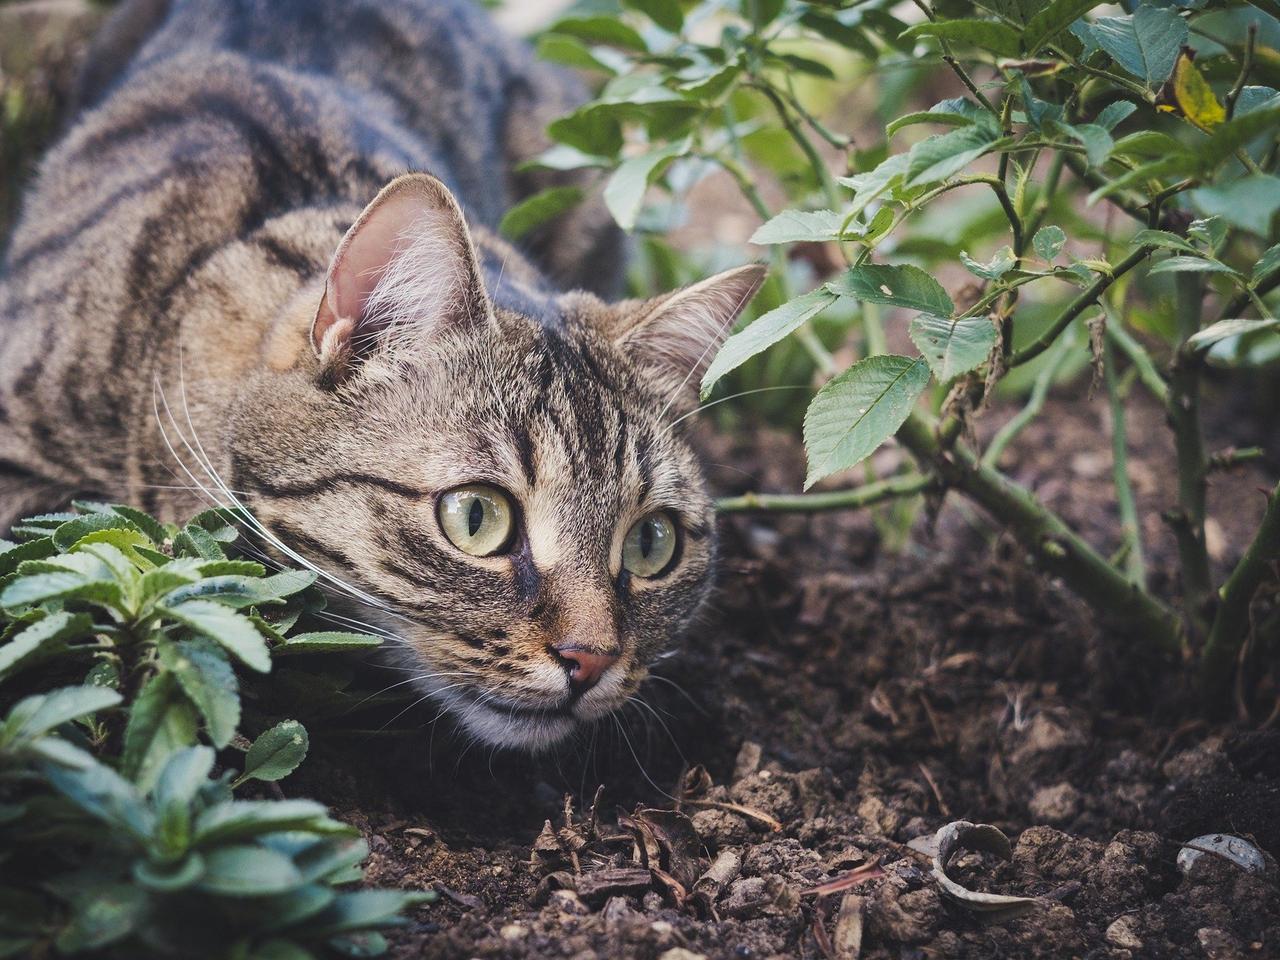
left=804, top=355, right=929, bottom=489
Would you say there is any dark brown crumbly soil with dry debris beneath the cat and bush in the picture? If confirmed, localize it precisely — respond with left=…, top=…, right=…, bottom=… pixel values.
left=280, top=386, right=1280, bottom=960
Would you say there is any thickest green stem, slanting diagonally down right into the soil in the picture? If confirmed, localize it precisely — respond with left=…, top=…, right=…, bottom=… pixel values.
left=897, top=411, right=1181, bottom=654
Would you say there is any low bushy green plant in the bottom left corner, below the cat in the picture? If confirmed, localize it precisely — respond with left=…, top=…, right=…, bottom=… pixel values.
left=0, top=504, right=430, bottom=960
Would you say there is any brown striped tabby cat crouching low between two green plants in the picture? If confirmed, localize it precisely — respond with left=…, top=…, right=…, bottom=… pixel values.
left=0, top=0, right=764, bottom=750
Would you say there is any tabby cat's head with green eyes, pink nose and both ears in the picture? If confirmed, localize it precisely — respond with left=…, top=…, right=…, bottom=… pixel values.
left=233, top=174, right=763, bottom=749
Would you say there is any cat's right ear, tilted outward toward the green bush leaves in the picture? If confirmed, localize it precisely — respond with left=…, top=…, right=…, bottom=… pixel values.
left=613, top=264, right=768, bottom=402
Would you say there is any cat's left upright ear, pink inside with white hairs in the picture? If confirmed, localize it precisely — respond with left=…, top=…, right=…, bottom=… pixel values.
left=311, top=173, right=492, bottom=383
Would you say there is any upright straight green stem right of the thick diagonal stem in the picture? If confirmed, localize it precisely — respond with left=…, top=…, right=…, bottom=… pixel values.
left=1166, top=273, right=1212, bottom=634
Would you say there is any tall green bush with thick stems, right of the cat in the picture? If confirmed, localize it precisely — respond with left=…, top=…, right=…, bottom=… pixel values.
left=531, top=0, right=1280, bottom=701
